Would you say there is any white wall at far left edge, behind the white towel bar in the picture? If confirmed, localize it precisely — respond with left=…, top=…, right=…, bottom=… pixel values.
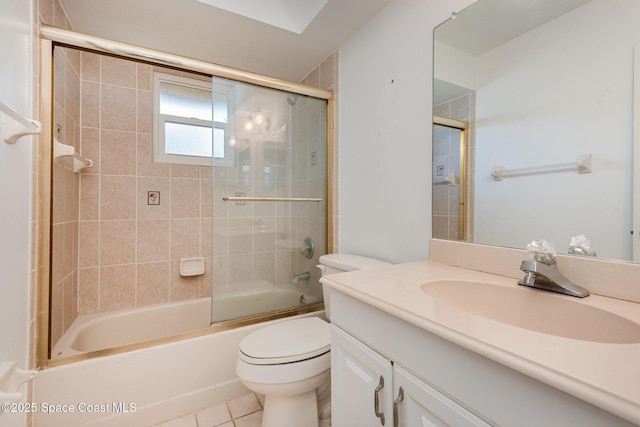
left=0, top=0, right=34, bottom=427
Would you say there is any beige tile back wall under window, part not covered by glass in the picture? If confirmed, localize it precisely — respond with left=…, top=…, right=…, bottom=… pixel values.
left=78, top=56, right=212, bottom=314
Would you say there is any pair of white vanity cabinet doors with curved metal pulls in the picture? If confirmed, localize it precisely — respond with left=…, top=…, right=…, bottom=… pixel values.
left=331, top=325, right=489, bottom=427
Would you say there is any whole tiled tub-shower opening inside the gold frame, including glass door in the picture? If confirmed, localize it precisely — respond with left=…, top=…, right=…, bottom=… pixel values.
left=47, top=46, right=327, bottom=359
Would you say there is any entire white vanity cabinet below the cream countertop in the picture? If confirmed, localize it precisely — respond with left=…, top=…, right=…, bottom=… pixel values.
left=330, top=288, right=633, bottom=427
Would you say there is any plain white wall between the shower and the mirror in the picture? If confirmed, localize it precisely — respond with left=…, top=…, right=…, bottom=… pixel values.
left=339, top=0, right=472, bottom=262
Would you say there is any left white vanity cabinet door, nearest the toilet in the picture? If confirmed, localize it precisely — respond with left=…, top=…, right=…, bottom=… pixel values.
left=331, top=325, right=393, bottom=427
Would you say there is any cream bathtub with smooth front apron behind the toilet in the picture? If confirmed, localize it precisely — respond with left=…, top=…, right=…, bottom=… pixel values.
left=33, top=286, right=324, bottom=427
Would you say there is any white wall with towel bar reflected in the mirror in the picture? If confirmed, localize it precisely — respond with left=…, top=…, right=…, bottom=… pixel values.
left=475, top=0, right=640, bottom=260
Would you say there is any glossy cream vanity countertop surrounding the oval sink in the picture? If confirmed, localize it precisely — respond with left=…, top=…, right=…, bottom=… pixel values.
left=322, top=261, right=640, bottom=424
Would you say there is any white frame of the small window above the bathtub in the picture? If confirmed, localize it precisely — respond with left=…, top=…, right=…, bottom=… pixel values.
left=153, top=71, right=235, bottom=167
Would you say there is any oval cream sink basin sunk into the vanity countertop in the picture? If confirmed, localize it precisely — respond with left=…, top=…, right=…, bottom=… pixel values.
left=421, top=280, right=640, bottom=344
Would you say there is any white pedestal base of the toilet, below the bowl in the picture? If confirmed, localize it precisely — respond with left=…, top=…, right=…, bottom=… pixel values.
left=262, top=390, right=318, bottom=427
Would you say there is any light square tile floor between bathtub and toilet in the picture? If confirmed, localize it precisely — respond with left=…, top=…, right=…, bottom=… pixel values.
left=153, top=393, right=262, bottom=427
